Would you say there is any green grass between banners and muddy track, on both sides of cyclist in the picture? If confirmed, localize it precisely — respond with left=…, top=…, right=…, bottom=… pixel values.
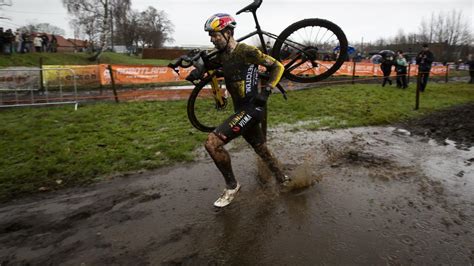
left=0, top=83, right=474, bottom=201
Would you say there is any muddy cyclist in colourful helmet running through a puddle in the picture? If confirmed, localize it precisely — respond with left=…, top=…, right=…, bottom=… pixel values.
left=204, top=13, right=290, bottom=207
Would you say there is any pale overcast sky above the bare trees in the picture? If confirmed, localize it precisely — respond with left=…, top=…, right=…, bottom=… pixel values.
left=0, top=0, right=474, bottom=46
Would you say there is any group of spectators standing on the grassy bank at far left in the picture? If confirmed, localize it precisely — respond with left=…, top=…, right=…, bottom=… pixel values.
left=0, top=27, right=58, bottom=55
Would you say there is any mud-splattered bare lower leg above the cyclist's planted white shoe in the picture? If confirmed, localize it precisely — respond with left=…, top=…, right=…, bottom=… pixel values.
left=204, top=133, right=237, bottom=189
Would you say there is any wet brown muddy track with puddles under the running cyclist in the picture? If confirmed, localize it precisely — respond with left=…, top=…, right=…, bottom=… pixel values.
left=0, top=106, right=474, bottom=265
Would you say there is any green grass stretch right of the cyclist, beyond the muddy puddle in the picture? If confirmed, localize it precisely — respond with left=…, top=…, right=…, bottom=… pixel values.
left=269, top=82, right=474, bottom=129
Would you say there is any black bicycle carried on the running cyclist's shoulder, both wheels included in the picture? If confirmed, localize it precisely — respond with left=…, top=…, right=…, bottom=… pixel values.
left=168, top=0, right=348, bottom=132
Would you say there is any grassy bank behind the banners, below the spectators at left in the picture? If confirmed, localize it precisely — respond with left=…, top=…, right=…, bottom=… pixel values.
left=0, top=52, right=170, bottom=68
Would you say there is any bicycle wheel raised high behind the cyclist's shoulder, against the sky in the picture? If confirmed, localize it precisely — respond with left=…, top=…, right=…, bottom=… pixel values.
left=272, top=18, right=348, bottom=83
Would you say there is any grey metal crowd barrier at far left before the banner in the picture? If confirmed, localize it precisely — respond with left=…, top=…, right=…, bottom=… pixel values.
left=0, top=67, right=78, bottom=109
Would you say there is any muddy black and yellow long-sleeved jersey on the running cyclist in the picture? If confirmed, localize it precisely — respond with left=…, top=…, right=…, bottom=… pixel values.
left=212, top=43, right=284, bottom=110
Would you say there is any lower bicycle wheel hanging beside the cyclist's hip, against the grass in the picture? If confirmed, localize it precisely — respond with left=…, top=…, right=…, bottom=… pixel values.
left=187, top=78, right=234, bottom=132
